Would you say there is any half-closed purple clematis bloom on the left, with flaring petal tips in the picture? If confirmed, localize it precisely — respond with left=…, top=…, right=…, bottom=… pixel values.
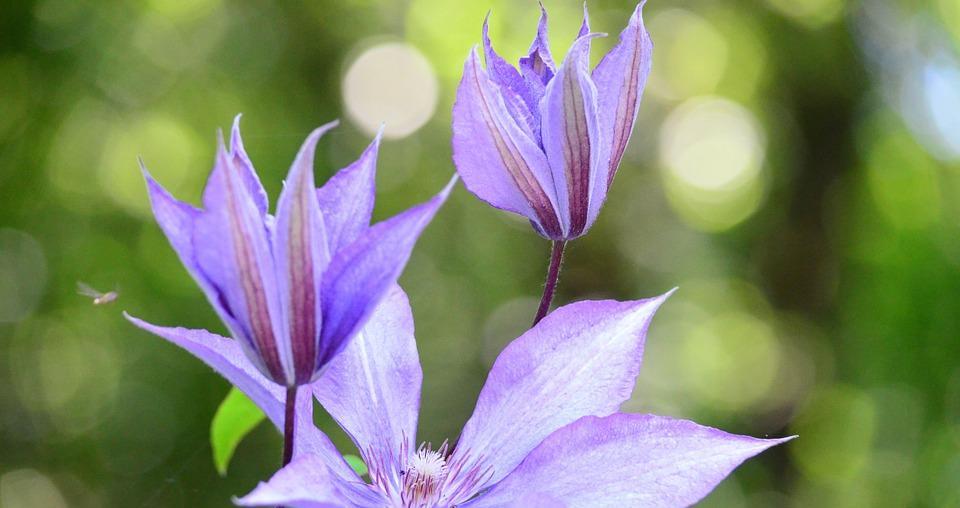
left=130, top=115, right=453, bottom=387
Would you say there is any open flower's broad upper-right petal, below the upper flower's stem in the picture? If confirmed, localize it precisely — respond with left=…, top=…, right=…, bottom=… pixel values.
left=451, top=293, right=669, bottom=489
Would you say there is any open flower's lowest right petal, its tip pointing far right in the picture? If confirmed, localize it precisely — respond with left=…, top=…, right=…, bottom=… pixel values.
left=469, top=413, right=793, bottom=508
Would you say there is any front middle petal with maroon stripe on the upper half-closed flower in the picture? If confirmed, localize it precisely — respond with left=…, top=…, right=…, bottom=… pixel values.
left=541, top=34, right=605, bottom=239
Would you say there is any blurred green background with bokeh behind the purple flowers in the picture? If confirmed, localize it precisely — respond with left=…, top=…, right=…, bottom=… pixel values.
left=0, top=0, right=960, bottom=508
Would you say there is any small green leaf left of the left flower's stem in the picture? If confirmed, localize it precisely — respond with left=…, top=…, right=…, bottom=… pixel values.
left=210, top=387, right=266, bottom=476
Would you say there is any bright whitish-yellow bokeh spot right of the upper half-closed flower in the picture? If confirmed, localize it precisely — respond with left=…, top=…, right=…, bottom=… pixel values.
left=659, top=97, right=766, bottom=231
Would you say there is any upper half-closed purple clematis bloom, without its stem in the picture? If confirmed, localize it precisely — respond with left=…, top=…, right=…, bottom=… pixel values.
left=453, top=2, right=653, bottom=241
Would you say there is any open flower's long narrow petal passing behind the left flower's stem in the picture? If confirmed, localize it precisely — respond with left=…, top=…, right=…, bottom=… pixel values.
left=124, top=313, right=359, bottom=481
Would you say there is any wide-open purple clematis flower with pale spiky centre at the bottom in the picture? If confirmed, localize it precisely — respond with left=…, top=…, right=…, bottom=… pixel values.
left=167, top=288, right=791, bottom=508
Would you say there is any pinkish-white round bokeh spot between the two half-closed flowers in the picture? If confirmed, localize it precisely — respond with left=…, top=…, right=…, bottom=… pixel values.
left=343, top=42, right=439, bottom=138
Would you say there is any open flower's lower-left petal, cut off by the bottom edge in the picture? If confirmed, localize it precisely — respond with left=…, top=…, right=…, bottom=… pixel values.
left=234, top=455, right=383, bottom=508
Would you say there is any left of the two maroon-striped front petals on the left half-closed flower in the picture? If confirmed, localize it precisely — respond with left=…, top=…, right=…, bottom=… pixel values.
left=192, top=139, right=284, bottom=384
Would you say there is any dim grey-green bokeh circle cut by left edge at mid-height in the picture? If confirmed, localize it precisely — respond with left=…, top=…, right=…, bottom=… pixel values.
left=0, top=229, right=47, bottom=323
